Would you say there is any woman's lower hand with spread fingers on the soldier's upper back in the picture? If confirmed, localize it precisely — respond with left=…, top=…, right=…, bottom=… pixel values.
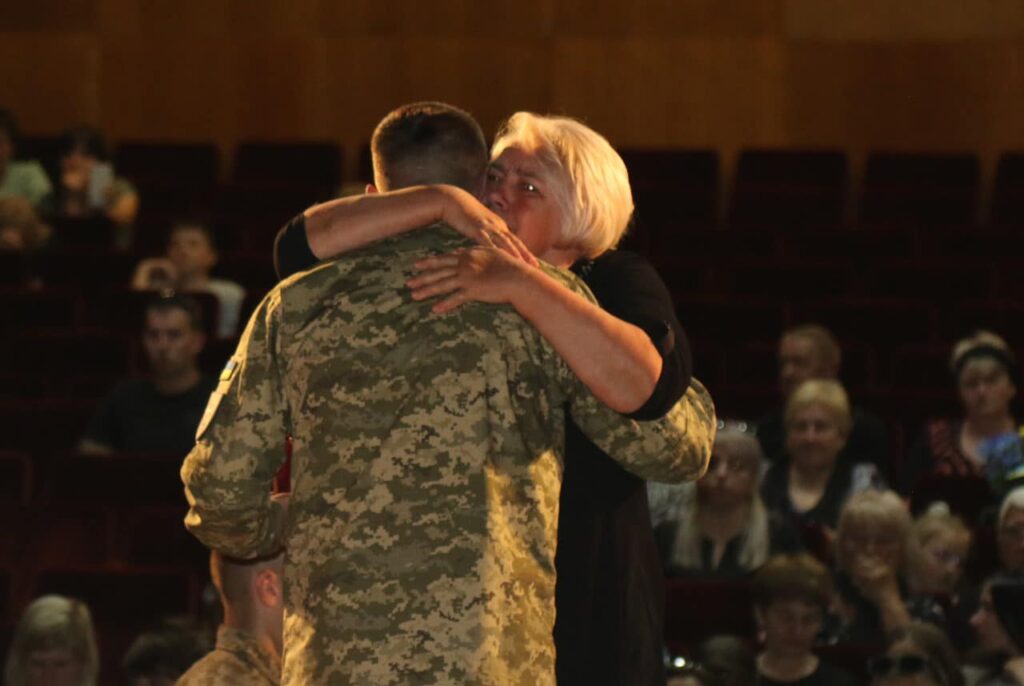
left=406, top=247, right=532, bottom=314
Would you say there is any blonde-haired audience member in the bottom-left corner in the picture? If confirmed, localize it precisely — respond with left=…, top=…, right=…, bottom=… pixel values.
left=4, top=596, right=99, bottom=686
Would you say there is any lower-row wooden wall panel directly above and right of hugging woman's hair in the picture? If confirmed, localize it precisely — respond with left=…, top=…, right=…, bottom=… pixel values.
left=554, top=38, right=783, bottom=148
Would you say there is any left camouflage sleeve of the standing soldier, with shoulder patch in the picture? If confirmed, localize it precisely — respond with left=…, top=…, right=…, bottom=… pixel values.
left=181, top=291, right=288, bottom=558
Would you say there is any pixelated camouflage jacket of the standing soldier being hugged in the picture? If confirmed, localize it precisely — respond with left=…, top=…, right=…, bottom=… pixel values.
left=182, top=228, right=715, bottom=686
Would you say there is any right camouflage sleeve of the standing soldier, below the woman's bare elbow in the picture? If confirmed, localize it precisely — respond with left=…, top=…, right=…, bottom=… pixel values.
left=569, top=379, right=717, bottom=483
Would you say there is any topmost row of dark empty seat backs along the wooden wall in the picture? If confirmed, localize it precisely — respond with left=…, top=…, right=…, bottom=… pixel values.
left=19, top=137, right=1024, bottom=233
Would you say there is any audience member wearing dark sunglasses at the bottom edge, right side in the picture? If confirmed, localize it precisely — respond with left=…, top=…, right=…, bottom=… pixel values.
left=867, top=621, right=965, bottom=686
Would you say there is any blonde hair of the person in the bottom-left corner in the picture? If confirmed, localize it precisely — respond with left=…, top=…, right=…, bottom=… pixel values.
left=4, top=595, right=99, bottom=686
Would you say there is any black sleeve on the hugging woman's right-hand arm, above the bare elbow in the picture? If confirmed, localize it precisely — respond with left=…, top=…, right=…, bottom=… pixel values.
left=578, top=250, right=693, bottom=420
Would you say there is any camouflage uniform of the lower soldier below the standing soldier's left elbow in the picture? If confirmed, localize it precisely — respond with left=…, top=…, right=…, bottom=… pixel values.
left=176, top=625, right=281, bottom=686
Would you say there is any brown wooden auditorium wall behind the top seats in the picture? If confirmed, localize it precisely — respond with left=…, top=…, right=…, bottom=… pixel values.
left=0, top=0, right=1024, bottom=186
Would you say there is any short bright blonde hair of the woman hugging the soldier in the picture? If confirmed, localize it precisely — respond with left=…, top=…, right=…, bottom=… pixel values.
left=490, top=112, right=633, bottom=257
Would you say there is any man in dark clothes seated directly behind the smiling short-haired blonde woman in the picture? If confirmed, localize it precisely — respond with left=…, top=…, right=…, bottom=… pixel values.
left=757, top=324, right=891, bottom=474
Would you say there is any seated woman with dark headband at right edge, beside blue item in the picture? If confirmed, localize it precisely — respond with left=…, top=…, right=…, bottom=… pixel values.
left=903, top=331, right=1019, bottom=497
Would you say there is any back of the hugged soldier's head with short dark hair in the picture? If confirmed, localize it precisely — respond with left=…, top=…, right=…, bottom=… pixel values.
left=370, top=102, right=487, bottom=194
